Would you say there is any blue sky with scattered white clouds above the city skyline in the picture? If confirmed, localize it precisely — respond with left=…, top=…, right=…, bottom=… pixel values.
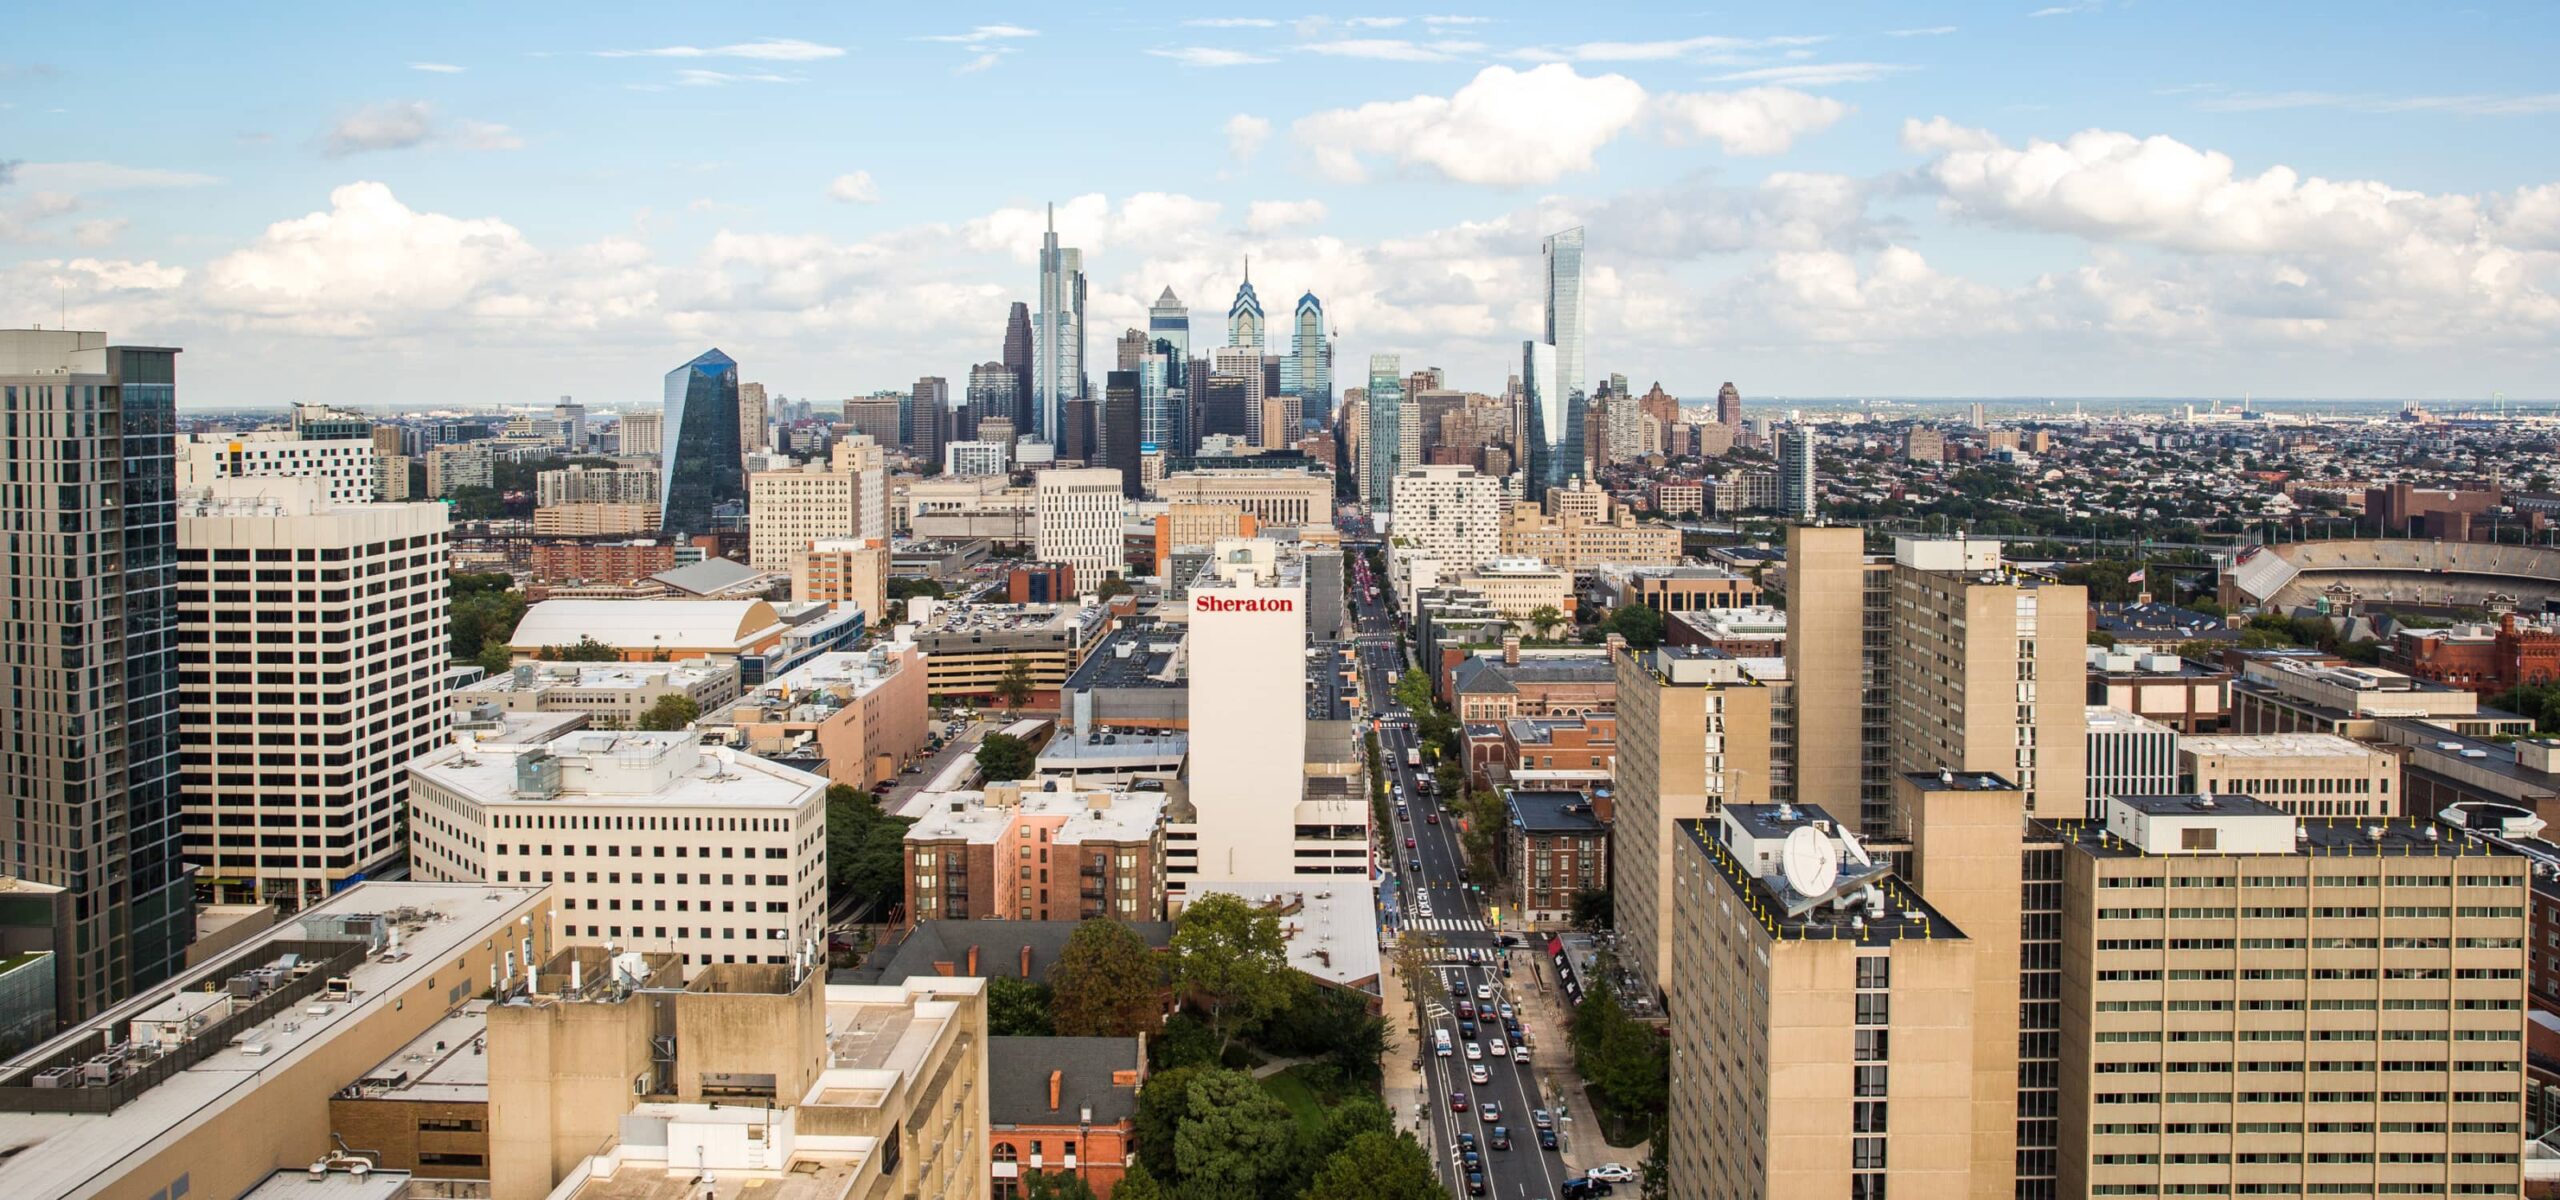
left=0, top=0, right=2560, bottom=407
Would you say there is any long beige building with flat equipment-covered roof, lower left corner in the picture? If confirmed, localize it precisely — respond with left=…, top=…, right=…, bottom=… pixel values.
left=0, top=880, right=555, bottom=1200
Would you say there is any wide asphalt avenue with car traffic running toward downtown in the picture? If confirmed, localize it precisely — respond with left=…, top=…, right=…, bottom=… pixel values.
left=1354, top=552, right=1574, bottom=1200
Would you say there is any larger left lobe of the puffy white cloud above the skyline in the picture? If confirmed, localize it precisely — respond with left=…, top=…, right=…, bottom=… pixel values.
left=1293, top=64, right=1646, bottom=187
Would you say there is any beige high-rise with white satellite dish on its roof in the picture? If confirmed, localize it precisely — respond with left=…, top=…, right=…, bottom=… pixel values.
left=1664, top=803, right=1976, bottom=1200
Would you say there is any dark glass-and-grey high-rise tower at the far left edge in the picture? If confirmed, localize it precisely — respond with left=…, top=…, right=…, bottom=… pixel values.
left=0, top=330, right=190, bottom=1021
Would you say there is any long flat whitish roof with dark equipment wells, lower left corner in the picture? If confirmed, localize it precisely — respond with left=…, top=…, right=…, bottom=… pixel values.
left=0, top=880, right=543, bottom=1197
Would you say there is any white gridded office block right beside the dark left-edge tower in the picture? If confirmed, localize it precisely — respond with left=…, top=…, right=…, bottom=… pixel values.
left=177, top=478, right=453, bottom=908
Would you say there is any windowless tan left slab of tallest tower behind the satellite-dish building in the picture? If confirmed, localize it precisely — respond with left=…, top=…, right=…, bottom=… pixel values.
left=1787, top=525, right=1892, bottom=837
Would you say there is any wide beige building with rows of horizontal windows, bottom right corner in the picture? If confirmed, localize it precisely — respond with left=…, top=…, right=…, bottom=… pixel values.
left=2058, top=796, right=2532, bottom=1195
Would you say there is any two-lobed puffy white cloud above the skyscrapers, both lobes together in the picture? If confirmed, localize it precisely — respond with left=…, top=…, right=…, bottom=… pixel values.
left=1293, top=64, right=1848, bottom=187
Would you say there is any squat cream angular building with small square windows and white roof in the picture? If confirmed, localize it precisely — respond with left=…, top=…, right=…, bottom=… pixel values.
left=410, top=732, right=827, bottom=975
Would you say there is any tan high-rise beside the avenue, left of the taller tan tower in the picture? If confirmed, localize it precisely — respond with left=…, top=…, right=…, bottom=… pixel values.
left=1610, top=647, right=1769, bottom=993
